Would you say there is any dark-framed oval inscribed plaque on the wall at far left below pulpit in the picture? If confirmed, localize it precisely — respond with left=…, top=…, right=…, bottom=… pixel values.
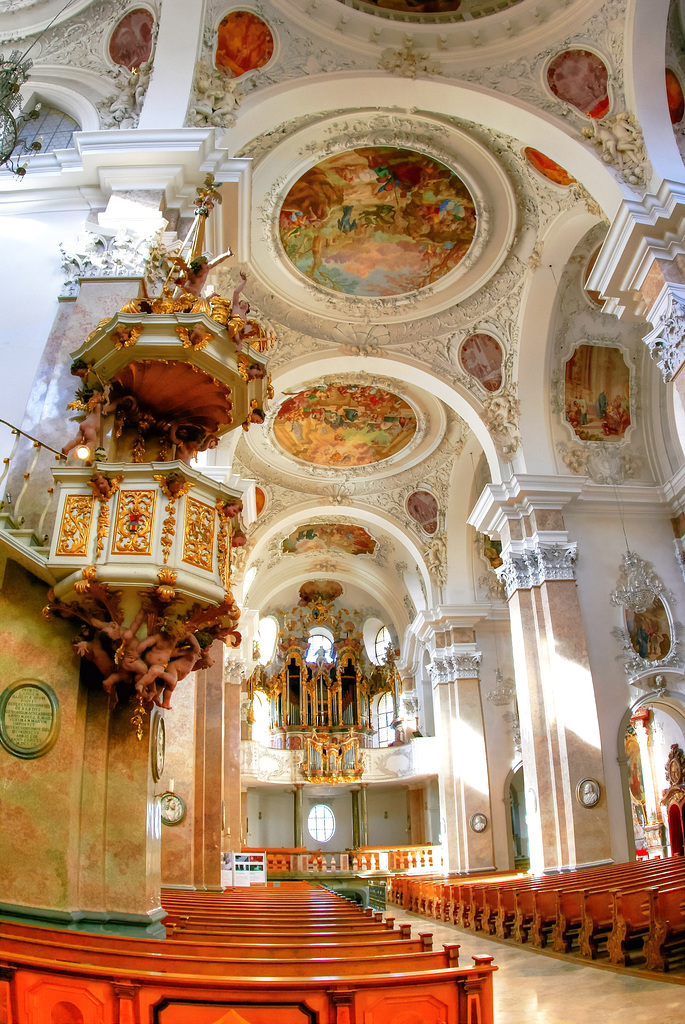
left=0, top=679, right=59, bottom=759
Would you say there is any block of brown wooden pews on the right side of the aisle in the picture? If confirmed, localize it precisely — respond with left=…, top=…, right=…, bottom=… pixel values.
left=387, top=857, right=685, bottom=971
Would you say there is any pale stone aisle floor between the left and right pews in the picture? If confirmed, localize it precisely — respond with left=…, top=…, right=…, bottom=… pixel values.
left=388, top=907, right=685, bottom=1024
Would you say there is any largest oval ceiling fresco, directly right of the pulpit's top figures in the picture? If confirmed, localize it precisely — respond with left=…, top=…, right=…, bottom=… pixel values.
left=279, top=146, right=476, bottom=298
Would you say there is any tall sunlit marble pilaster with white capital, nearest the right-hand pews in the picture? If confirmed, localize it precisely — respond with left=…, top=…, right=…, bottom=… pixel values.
left=471, top=480, right=611, bottom=871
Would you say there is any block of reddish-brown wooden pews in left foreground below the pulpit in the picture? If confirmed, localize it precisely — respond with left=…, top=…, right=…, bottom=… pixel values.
left=0, top=883, right=496, bottom=1024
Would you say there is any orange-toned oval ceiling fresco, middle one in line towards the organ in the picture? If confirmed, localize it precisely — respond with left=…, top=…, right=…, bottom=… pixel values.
left=273, top=384, right=417, bottom=467
